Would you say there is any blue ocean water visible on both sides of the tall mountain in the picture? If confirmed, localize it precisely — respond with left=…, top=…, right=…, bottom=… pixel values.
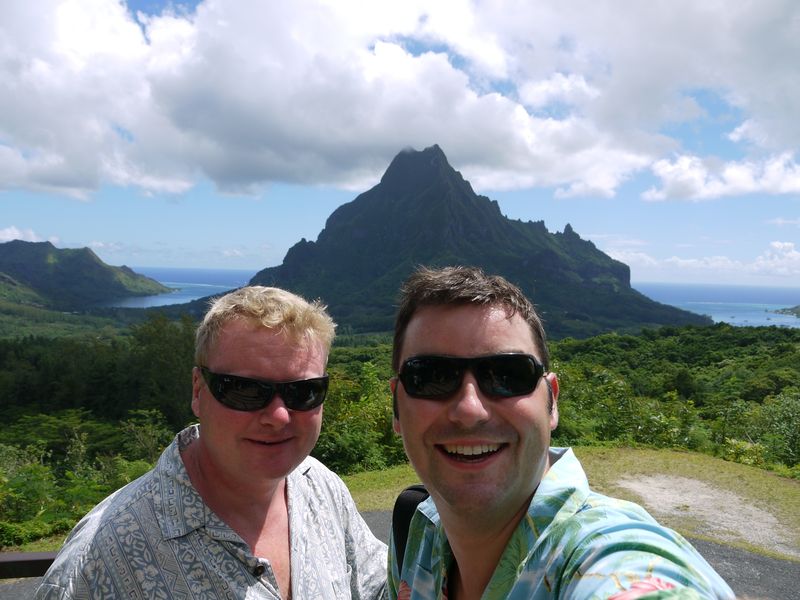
left=114, top=267, right=800, bottom=327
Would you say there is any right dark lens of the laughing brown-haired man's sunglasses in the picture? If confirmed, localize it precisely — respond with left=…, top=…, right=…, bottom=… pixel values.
left=474, top=354, right=543, bottom=398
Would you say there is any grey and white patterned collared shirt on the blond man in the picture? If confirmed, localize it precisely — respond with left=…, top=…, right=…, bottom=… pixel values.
left=36, top=426, right=386, bottom=600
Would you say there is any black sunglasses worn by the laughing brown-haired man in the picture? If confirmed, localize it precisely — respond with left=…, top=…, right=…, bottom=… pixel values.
left=398, top=353, right=544, bottom=400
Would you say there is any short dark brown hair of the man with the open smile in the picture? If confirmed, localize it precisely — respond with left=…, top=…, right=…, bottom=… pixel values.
left=392, top=266, right=550, bottom=373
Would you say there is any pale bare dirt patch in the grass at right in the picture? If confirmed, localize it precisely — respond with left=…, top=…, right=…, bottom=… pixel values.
left=617, top=475, right=800, bottom=559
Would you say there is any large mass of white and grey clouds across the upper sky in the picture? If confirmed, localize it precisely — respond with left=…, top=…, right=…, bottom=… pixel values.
left=0, top=0, right=800, bottom=199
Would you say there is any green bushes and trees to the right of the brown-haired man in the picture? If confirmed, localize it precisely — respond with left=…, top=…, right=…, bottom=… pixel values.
left=553, top=324, right=800, bottom=468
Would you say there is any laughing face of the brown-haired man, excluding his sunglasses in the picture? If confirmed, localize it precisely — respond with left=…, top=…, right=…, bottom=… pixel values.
left=393, top=305, right=558, bottom=518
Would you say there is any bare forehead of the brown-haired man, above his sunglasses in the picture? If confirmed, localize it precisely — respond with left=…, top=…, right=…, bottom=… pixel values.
left=400, top=304, right=541, bottom=361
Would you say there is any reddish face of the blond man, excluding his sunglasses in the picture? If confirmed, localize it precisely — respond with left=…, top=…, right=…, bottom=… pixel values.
left=192, top=319, right=327, bottom=487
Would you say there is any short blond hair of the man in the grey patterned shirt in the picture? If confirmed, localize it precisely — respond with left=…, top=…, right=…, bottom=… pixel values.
left=194, top=285, right=336, bottom=366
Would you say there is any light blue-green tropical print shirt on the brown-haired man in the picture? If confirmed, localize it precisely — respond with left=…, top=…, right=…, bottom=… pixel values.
left=389, top=448, right=734, bottom=600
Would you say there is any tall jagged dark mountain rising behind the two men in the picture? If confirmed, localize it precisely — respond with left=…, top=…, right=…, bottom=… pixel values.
left=251, top=145, right=706, bottom=337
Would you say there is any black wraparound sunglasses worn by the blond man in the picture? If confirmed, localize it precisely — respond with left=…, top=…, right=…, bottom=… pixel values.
left=200, top=367, right=328, bottom=411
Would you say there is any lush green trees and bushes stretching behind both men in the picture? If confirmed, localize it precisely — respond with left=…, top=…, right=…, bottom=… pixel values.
left=0, top=315, right=800, bottom=547
